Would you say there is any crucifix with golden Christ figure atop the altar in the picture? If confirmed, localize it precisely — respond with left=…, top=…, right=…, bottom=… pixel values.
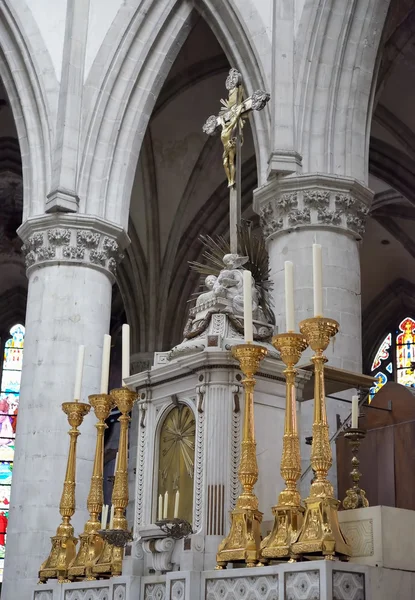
left=203, top=69, right=270, bottom=254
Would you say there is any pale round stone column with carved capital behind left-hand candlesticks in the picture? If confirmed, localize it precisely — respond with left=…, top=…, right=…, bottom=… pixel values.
left=2, top=214, right=128, bottom=600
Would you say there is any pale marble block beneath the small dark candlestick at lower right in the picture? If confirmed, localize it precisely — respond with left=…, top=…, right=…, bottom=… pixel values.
left=339, top=506, right=415, bottom=568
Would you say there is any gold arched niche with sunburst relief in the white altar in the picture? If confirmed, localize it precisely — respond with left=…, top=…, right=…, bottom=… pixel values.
left=157, top=404, right=196, bottom=523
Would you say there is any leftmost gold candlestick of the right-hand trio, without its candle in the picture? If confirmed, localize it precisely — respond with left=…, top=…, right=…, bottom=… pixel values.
left=216, top=344, right=267, bottom=569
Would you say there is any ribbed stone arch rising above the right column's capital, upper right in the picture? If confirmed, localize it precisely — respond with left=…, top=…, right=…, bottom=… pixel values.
left=295, top=0, right=390, bottom=182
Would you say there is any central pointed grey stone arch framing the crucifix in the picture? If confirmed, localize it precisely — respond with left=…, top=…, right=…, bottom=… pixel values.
left=79, top=0, right=271, bottom=226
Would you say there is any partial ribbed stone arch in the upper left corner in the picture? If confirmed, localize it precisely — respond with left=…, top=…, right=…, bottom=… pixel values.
left=0, top=0, right=57, bottom=220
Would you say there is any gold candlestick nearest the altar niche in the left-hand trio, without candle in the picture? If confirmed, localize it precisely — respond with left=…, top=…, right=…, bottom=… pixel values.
left=92, top=388, right=137, bottom=577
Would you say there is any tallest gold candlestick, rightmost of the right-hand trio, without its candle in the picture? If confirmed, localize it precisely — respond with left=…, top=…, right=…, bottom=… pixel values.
left=292, top=317, right=351, bottom=559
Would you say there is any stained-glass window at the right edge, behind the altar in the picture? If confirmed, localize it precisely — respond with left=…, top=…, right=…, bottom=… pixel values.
left=370, top=317, right=415, bottom=399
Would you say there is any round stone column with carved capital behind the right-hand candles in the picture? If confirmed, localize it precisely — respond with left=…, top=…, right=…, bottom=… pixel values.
left=255, top=174, right=372, bottom=495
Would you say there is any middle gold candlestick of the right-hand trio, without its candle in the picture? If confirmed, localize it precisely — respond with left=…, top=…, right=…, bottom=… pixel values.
left=261, top=332, right=308, bottom=563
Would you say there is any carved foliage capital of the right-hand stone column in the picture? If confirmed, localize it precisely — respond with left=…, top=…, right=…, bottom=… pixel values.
left=254, top=174, right=373, bottom=240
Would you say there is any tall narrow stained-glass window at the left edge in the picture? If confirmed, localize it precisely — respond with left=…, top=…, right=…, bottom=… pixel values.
left=0, top=325, right=25, bottom=581
